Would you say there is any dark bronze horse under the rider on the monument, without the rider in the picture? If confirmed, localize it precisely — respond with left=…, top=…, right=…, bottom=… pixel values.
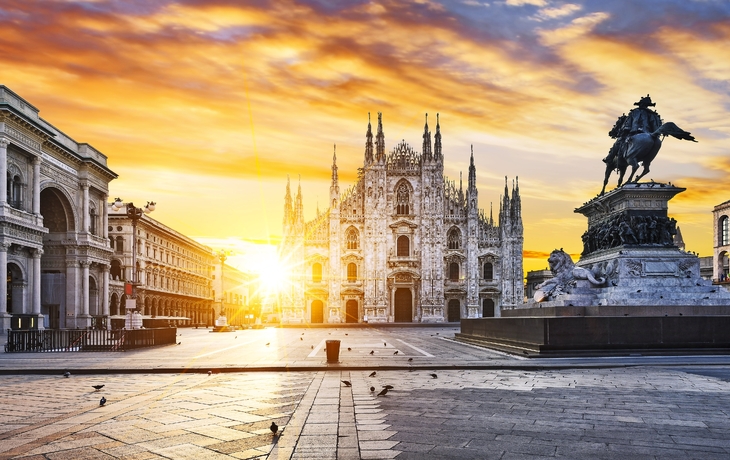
left=601, top=119, right=697, bottom=195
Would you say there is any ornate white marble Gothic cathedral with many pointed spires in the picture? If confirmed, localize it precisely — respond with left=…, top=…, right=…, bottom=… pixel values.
left=279, top=113, right=524, bottom=324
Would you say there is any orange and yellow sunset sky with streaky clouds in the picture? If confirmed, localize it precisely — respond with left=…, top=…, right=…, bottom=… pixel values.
left=0, top=0, right=730, bottom=270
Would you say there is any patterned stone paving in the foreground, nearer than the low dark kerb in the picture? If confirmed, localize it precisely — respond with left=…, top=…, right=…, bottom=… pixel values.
left=0, top=366, right=730, bottom=460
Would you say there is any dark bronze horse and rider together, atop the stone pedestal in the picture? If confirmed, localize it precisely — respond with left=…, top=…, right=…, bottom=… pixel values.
left=601, top=94, right=697, bottom=195
